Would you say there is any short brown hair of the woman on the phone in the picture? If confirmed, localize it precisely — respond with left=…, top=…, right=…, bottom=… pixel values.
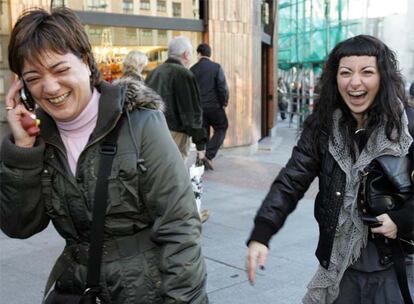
left=9, top=7, right=100, bottom=85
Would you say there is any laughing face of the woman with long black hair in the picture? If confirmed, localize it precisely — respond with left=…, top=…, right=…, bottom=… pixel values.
left=336, top=56, right=380, bottom=127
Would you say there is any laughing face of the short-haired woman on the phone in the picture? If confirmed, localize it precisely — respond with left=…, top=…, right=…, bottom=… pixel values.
left=22, top=52, right=92, bottom=121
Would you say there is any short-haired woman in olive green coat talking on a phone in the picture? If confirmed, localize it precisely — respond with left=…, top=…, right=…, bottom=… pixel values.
left=0, top=8, right=208, bottom=304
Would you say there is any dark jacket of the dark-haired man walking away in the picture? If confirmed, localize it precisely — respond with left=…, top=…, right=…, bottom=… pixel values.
left=190, top=57, right=229, bottom=109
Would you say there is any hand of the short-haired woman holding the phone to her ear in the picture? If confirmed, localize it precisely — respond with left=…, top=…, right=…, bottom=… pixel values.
left=5, top=79, right=36, bottom=148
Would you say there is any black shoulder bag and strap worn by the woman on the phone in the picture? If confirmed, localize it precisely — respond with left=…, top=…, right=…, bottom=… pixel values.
left=43, top=119, right=119, bottom=304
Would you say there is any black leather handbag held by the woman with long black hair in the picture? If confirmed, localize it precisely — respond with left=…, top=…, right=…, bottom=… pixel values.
left=358, top=155, right=414, bottom=304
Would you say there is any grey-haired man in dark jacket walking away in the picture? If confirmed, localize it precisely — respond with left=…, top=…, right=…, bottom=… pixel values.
left=146, top=36, right=206, bottom=160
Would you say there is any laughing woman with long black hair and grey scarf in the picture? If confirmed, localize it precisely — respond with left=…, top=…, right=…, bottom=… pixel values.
left=246, top=35, right=414, bottom=304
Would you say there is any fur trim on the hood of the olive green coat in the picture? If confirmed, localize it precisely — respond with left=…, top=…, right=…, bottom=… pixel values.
left=113, top=76, right=165, bottom=112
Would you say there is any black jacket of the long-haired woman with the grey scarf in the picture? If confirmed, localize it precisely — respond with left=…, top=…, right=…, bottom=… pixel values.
left=248, top=108, right=414, bottom=269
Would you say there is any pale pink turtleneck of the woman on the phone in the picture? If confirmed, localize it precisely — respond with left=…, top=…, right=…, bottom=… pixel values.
left=56, top=89, right=101, bottom=176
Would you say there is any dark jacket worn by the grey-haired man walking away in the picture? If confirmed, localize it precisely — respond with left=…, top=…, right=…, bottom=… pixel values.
left=145, top=58, right=206, bottom=150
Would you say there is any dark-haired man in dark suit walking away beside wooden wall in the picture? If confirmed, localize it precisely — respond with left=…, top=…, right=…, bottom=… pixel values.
left=190, top=43, right=229, bottom=170
